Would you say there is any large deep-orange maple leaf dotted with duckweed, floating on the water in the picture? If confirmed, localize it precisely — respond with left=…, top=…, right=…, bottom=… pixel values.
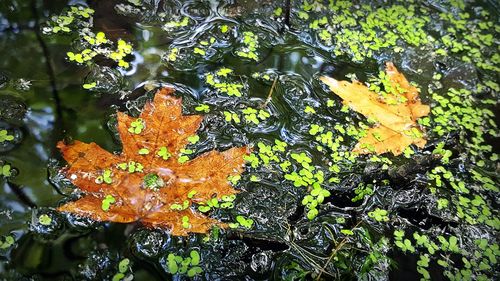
left=57, top=88, right=249, bottom=235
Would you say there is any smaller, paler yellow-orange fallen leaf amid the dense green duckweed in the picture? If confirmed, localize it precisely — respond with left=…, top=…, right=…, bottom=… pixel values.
left=320, top=62, right=430, bottom=155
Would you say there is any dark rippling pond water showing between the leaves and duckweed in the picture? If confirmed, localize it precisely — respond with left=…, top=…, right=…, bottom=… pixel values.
left=0, top=0, right=499, bottom=280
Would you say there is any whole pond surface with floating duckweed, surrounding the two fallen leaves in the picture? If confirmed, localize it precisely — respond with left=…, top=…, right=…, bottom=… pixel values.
left=0, top=0, right=500, bottom=280
